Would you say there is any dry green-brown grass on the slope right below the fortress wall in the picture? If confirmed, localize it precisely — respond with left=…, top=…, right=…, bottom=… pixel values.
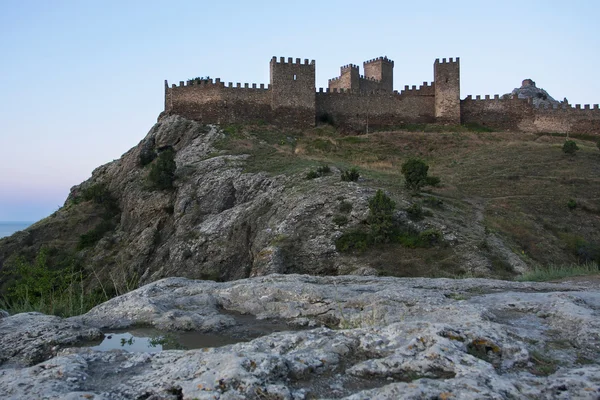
left=212, top=124, right=600, bottom=279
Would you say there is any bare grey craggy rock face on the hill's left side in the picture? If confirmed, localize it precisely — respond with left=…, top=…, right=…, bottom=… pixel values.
left=0, top=116, right=526, bottom=293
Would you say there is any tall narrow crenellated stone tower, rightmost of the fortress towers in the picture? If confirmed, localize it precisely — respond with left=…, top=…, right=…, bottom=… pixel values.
left=433, top=57, right=460, bottom=125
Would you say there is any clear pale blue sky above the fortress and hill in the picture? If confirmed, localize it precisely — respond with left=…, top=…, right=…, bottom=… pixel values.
left=0, top=0, right=600, bottom=221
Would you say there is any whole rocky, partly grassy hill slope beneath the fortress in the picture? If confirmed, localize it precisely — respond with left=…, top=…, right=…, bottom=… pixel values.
left=0, top=116, right=600, bottom=297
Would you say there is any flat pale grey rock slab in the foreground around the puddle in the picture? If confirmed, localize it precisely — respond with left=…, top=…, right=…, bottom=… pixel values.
left=0, top=275, right=600, bottom=399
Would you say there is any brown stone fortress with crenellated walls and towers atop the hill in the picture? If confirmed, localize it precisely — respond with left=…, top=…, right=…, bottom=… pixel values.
left=159, top=57, right=600, bottom=134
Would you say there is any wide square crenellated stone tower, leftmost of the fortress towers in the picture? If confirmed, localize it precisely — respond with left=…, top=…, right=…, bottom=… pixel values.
left=270, top=57, right=315, bottom=126
